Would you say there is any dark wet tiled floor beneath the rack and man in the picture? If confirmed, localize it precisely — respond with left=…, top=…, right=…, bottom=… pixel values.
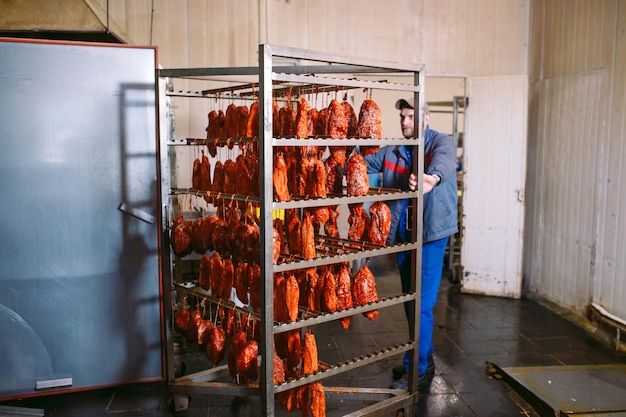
left=0, top=257, right=626, bottom=417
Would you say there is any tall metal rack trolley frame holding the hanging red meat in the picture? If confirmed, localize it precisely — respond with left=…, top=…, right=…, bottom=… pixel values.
left=158, top=45, right=424, bottom=416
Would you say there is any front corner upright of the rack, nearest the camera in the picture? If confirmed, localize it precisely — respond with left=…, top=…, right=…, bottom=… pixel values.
left=259, top=44, right=274, bottom=416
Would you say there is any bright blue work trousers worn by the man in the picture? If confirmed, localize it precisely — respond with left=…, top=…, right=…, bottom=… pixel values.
left=397, top=237, right=448, bottom=375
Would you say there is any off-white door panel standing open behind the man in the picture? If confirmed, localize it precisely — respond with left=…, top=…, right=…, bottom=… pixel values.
left=461, top=76, right=528, bottom=298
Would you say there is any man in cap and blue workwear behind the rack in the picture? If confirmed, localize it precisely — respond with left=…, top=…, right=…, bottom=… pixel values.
left=358, top=99, right=458, bottom=391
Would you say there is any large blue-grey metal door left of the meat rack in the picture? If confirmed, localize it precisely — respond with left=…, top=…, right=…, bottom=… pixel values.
left=0, top=40, right=163, bottom=397
